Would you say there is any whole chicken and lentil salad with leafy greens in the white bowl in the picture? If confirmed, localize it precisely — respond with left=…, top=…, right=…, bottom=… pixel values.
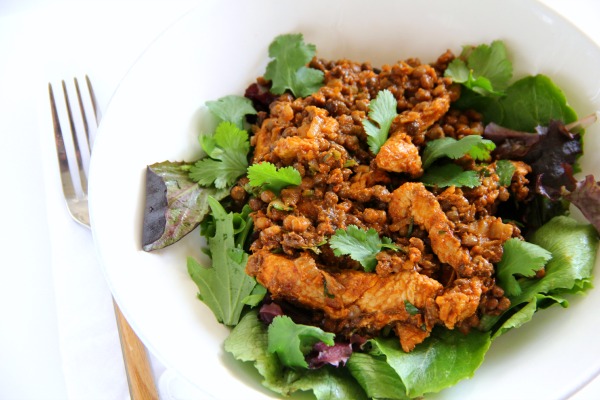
left=143, top=34, right=600, bottom=399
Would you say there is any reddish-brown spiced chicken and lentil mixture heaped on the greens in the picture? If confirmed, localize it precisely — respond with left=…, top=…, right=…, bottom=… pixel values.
left=241, top=52, right=530, bottom=351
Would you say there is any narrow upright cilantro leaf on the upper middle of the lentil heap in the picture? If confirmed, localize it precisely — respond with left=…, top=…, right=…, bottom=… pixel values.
left=362, top=89, right=398, bottom=154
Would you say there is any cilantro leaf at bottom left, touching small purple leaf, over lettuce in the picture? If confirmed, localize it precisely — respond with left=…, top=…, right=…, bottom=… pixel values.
left=268, top=315, right=335, bottom=368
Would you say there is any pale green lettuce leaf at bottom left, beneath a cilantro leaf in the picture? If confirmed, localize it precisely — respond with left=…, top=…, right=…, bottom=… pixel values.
left=224, top=310, right=367, bottom=400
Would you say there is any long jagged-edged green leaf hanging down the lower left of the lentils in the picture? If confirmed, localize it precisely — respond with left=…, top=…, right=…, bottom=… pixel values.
left=187, top=197, right=256, bottom=326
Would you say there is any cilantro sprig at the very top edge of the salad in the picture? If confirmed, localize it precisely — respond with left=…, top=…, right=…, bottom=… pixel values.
left=265, top=34, right=323, bottom=97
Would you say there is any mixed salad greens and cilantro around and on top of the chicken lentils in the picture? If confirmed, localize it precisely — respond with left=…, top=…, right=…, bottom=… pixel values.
left=143, top=34, right=600, bottom=400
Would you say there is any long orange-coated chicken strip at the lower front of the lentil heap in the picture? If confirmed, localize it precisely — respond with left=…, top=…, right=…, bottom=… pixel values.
left=246, top=251, right=443, bottom=351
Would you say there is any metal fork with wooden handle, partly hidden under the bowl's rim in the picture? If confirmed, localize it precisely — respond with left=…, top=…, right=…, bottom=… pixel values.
left=48, top=76, right=158, bottom=400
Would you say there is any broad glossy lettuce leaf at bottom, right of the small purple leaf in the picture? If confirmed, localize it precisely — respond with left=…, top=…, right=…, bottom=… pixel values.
left=370, top=328, right=491, bottom=398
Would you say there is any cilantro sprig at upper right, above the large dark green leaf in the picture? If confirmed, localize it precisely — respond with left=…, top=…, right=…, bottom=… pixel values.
left=445, top=40, right=512, bottom=95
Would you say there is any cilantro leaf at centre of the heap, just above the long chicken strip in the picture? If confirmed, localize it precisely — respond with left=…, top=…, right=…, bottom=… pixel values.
left=329, top=225, right=400, bottom=272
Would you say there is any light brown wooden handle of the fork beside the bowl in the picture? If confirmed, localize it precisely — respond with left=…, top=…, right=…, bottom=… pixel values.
left=113, top=300, right=158, bottom=400
